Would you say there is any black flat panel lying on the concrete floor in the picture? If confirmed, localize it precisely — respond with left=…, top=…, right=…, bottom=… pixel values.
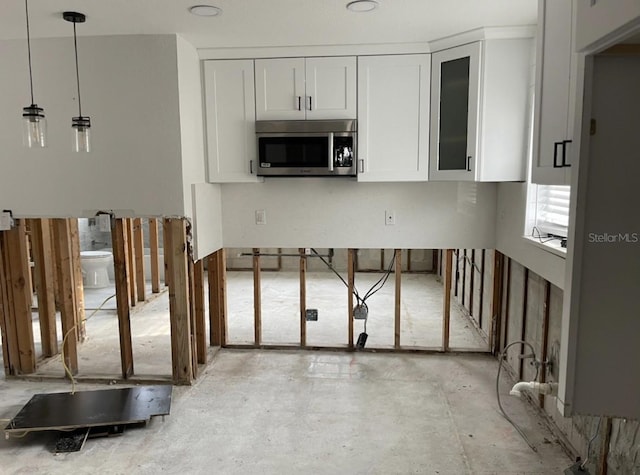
left=5, top=385, right=173, bottom=433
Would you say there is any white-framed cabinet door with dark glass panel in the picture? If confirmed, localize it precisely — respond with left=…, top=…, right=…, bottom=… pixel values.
left=429, top=42, right=481, bottom=181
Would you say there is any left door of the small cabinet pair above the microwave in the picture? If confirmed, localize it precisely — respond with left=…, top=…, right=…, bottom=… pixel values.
left=255, top=58, right=306, bottom=120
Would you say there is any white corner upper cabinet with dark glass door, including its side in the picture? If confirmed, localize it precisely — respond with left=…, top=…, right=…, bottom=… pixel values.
left=429, top=39, right=531, bottom=181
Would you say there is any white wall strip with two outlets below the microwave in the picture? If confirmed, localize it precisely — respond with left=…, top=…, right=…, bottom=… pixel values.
left=221, top=178, right=496, bottom=248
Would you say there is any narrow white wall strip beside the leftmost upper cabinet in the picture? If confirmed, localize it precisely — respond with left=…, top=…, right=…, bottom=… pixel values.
left=177, top=36, right=205, bottom=217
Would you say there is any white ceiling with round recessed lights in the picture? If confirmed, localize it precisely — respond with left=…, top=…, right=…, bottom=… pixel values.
left=0, top=0, right=538, bottom=48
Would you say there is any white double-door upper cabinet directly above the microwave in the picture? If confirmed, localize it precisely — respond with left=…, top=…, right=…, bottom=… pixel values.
left=255, top=56, right=356, bottom=120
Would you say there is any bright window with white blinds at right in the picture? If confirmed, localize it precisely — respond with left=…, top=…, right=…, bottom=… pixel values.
left=531, top=185, right=571, bottom=247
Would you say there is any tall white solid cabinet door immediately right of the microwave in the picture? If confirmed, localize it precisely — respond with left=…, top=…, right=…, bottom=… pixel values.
left=357, top=54, right=431, bottom=181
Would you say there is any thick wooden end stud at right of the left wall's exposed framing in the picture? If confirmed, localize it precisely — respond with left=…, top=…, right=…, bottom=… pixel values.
left=164, top=218, right=193, bottom=384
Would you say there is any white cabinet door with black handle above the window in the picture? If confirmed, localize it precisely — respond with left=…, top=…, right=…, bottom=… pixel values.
left=531, top=0, right=572, bottom=185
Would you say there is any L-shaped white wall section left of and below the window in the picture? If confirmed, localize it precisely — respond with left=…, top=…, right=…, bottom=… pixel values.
left=496, top=183, right=565, bottom=289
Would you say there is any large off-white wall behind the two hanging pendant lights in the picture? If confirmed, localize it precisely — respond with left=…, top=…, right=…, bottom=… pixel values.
left=0, top=35, right=185, bottom=217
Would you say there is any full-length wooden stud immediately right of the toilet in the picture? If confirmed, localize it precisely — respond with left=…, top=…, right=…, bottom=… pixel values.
left=111, top=218, right=133, bottom=379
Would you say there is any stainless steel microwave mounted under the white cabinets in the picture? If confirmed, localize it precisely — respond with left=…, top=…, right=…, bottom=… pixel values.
left=256, top=119, right=357, bottom=176
